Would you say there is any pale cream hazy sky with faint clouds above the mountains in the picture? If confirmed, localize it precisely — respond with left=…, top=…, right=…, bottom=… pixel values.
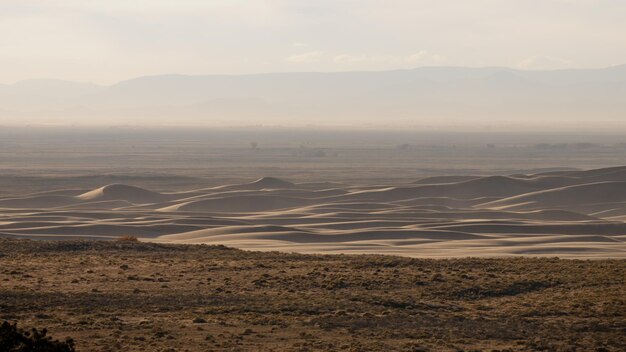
left=0, top=0, right=626, bottom=84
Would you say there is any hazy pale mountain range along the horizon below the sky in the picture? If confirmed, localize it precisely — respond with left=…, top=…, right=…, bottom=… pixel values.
left=0, top=65, right=626, bottom=125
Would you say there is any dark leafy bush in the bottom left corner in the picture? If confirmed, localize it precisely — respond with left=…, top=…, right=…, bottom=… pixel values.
left=0, top=321, right=76, bottom=352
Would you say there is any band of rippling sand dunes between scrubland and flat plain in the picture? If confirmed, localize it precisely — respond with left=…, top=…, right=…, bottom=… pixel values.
left=0, top=167, right=626, bottom=258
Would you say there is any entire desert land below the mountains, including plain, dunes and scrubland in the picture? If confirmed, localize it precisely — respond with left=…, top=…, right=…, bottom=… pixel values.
left=0, top=128, right=626, bottom=351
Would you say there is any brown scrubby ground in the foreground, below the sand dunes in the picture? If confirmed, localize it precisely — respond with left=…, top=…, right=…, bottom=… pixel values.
left=0, top=240, right=626, bottom=351
